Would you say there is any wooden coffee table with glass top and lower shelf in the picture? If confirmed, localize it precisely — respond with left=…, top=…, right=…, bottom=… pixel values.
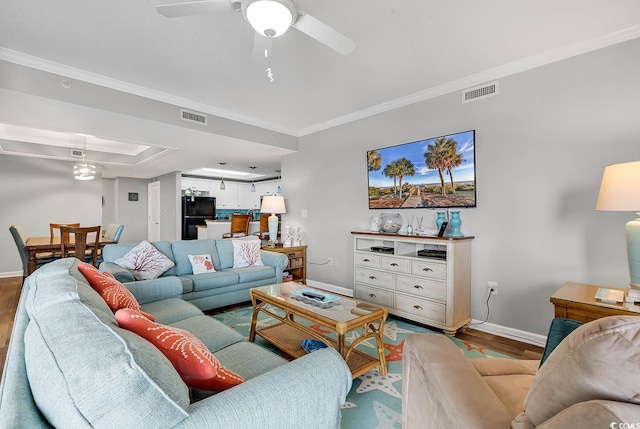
left=249, top=282, right=387, bottom=378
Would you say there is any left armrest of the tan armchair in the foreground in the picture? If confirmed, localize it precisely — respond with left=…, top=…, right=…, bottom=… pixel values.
left=402, top=334, right=514, bottom=429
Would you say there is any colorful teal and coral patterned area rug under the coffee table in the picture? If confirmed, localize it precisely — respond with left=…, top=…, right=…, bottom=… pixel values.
left=213, top=307, right=509, bottom=429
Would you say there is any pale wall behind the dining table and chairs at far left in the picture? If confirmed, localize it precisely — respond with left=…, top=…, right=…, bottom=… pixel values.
left=0, top=155, right=102, bottom=275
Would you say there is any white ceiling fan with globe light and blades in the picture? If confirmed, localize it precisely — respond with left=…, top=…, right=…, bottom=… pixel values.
left=156, top=0, right=356, bottom=55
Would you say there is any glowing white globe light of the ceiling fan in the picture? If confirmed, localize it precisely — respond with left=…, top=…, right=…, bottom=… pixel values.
left=244, top=0, right=296, bottom=37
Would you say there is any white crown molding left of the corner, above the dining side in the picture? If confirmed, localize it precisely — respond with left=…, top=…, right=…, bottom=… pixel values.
left=0, top=48, right=297, bottom=137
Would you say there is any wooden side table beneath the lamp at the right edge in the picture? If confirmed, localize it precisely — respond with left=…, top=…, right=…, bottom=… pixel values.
left=550, top=282, right=640, bottom=323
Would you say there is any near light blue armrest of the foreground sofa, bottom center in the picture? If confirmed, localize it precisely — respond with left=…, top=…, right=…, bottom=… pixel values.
left=176, top=349, right=351, bottom=429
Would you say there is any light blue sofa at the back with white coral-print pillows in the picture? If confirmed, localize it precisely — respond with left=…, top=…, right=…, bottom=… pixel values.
left=100, top=237, right=289, bottom=311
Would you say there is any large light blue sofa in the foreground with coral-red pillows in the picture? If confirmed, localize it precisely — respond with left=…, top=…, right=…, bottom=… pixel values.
left=0, top=258, right=351, bottom=429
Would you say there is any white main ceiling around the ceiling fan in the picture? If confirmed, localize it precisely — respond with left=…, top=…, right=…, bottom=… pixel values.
left=0, top=0, right=640, bottom=177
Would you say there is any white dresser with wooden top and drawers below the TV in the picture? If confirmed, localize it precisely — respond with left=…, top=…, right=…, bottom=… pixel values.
left=352, top=232, right=473, bottom=335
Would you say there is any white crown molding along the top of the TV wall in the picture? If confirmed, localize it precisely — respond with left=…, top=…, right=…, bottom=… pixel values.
left=297, top=24, right=640, bottom=137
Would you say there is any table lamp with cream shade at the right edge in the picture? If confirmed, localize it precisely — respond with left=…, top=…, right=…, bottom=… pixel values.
left=596, top=161, right=640, bottom=288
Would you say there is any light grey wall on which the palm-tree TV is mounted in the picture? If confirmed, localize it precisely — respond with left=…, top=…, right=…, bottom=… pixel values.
left=282, top=40, right=640, bottom=334
